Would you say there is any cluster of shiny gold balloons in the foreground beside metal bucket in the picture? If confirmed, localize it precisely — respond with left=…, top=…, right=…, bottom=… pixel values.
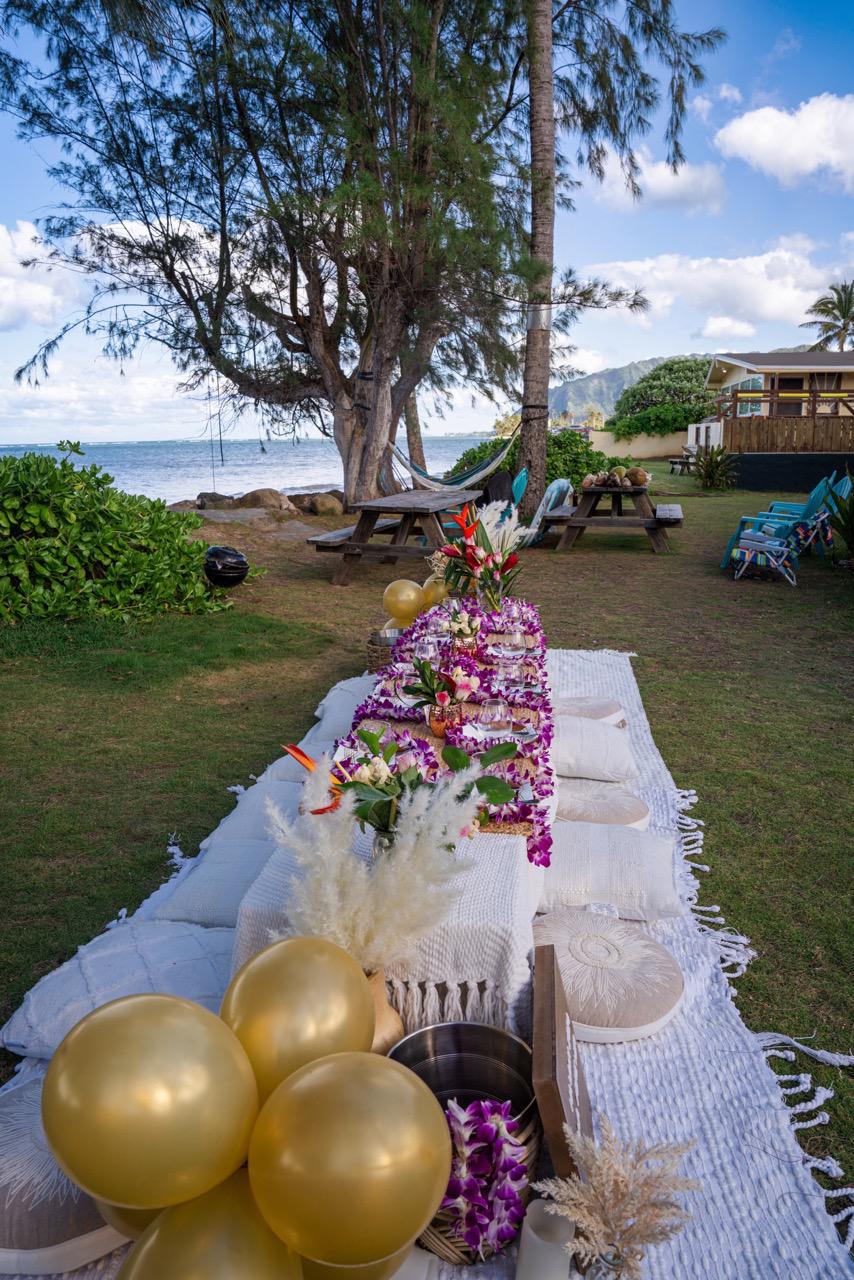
left=42, top=938, right=451, bottom=1280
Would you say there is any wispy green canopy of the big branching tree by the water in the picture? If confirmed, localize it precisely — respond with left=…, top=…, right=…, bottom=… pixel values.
left=0, top=0, right=720, bottom=499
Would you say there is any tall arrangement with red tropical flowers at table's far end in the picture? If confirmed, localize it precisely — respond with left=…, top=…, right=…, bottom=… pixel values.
left=440, top=502, right=526, bottom=611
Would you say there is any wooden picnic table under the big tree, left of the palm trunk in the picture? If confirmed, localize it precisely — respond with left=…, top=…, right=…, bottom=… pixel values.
left=306, top=489, right=481, bottom=586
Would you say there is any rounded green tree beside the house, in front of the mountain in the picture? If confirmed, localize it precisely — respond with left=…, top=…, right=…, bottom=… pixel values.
left=608, top=356, right=714, bottom=439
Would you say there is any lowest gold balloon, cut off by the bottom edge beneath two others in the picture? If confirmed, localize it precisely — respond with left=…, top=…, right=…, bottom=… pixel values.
left=113, top=1169, right=302, bottom=1280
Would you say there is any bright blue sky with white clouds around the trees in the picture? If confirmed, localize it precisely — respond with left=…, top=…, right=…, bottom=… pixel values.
left=0, top=0, right=854, bottom=443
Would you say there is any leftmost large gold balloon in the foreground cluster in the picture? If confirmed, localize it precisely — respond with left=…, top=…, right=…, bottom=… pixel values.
left=41, top=996, right=259, bottom=1208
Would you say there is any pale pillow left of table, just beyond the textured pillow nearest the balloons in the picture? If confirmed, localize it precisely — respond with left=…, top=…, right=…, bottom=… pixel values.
left=152, top=832, right=275, bottom=929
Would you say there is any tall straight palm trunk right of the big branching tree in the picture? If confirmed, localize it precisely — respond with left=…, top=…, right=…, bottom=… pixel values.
left=519, top=0, right=554, bottom=516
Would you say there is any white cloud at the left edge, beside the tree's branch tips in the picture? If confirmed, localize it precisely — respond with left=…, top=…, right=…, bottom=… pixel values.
left=0, top=221, right=81, bottom=330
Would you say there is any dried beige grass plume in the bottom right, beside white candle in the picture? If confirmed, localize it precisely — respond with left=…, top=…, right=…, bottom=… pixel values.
left=535, top=1116, right=699, bottom=1280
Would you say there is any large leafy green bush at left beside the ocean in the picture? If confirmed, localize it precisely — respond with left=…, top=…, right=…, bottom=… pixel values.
left=0, top=443, right=229, bottom=622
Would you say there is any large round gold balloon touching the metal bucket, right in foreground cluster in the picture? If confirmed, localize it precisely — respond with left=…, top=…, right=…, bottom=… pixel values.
left=250, top=1053, right=451, bottom=1265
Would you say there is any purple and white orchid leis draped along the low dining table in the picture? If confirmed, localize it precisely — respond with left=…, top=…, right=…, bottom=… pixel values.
left=347, top=598, right=554, bottom=867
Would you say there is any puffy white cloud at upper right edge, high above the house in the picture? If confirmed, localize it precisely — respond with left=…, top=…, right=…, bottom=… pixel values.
left=714, top=93, right=854, bottom=195
